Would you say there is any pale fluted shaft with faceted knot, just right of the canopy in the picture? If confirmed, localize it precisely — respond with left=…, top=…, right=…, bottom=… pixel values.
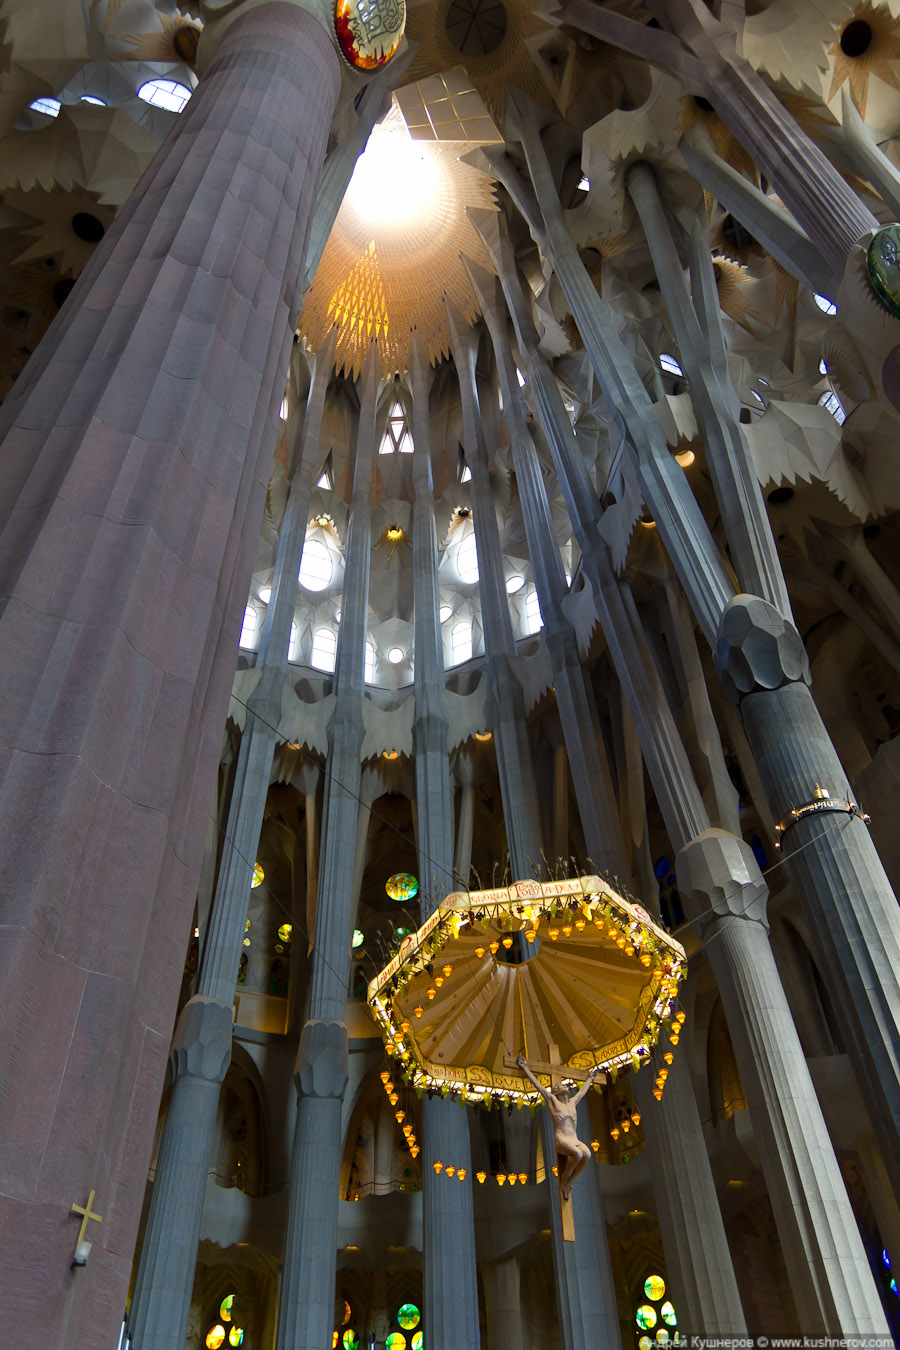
left=677, top=829, right=888, bottom=1337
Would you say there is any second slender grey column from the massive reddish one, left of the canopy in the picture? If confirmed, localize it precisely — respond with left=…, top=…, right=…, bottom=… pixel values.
left=275, top=344, right=381, bottom=1350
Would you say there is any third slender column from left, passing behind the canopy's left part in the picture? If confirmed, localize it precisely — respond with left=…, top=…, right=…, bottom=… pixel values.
left=409, top=335, right=480, bottom=1346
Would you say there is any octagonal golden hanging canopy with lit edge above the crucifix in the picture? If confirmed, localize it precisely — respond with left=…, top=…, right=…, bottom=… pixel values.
left=368, top=876, right=687, bottom=1102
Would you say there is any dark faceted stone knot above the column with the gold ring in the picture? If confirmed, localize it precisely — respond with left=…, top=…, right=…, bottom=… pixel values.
left=715, top=594, right=812, bottom=703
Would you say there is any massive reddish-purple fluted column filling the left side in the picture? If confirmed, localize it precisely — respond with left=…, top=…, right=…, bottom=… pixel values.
left=0, top=3, right=341, bottom=1345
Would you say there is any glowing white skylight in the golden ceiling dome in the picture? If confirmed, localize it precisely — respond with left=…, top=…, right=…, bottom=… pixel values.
left=345, top=127, right=437, bottom=224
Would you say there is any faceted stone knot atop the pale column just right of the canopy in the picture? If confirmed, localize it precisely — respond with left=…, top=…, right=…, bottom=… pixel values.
left=675, top=829, right=769, bottom=932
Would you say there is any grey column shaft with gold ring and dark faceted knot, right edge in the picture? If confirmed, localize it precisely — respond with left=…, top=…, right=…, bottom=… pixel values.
left=716, top=595, right=900, bottom=1189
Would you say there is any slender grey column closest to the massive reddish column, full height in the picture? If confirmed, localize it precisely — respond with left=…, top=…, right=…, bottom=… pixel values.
left=128, top=343, right=333, bottom=1350
